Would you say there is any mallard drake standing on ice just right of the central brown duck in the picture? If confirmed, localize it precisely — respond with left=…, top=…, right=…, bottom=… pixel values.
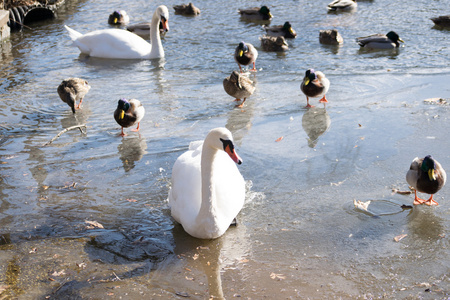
left=300, top=69, right=330, bottom=107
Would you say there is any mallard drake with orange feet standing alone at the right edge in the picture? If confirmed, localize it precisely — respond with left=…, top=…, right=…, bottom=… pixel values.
left=406, top=155, right=447, bottom=205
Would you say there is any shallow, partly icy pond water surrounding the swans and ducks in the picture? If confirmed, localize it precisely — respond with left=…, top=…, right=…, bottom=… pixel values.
left=0, top=0, right=450, bottom=299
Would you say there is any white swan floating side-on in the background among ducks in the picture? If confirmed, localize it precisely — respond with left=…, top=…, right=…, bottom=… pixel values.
left=64, top=5, right=169, bottom=59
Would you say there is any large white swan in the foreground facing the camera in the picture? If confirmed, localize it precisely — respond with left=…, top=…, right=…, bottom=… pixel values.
left=169, top=128, right=245, bottom=239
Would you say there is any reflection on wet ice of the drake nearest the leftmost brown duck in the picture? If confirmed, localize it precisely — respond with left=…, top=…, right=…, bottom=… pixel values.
left=117, top=136, right=147, bottom=172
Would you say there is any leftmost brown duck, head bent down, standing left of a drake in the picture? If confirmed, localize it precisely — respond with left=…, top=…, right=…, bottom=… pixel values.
left=57, top=78, right=91, bottom=113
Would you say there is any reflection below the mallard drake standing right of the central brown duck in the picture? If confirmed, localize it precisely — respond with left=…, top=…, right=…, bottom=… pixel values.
left=302, top=107, right=331, bottom=148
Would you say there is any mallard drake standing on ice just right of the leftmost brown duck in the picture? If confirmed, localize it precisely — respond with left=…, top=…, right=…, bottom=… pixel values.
left=114, top=98, right=145, bottom=136
